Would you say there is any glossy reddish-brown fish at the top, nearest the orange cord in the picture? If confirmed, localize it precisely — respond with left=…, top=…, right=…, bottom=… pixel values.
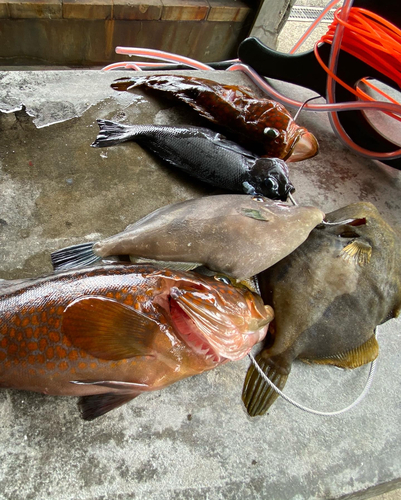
left=111, top=75, right=319, bottom=161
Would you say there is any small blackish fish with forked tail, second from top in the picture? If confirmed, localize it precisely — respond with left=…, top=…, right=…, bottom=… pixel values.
left=92, top=120, right=294, bottom=201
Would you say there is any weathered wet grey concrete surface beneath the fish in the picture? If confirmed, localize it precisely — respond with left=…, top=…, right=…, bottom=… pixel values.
left=0, top=71, right=401, bottom=500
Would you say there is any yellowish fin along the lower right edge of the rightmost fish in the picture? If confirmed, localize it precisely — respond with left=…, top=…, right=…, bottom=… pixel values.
left=300, top=335, right=379, bottom=369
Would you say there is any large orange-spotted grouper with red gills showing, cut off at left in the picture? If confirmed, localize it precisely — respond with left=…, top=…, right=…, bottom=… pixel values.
left=0, top=265, right=273, bottom=420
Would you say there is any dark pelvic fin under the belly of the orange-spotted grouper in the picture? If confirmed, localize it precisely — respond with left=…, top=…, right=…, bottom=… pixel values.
left=78, top=392, right=140, bottom=421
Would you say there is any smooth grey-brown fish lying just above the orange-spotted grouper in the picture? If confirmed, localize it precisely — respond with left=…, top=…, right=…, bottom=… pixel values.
left=51, top=194, right=324, bottom=279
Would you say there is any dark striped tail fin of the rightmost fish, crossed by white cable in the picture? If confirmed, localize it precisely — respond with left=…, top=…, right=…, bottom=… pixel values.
left=242, top=354, right=288, bottom=417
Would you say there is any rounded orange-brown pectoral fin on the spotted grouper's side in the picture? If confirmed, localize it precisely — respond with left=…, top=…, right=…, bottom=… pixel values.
left=62, top=297, right=159, bottom=360
